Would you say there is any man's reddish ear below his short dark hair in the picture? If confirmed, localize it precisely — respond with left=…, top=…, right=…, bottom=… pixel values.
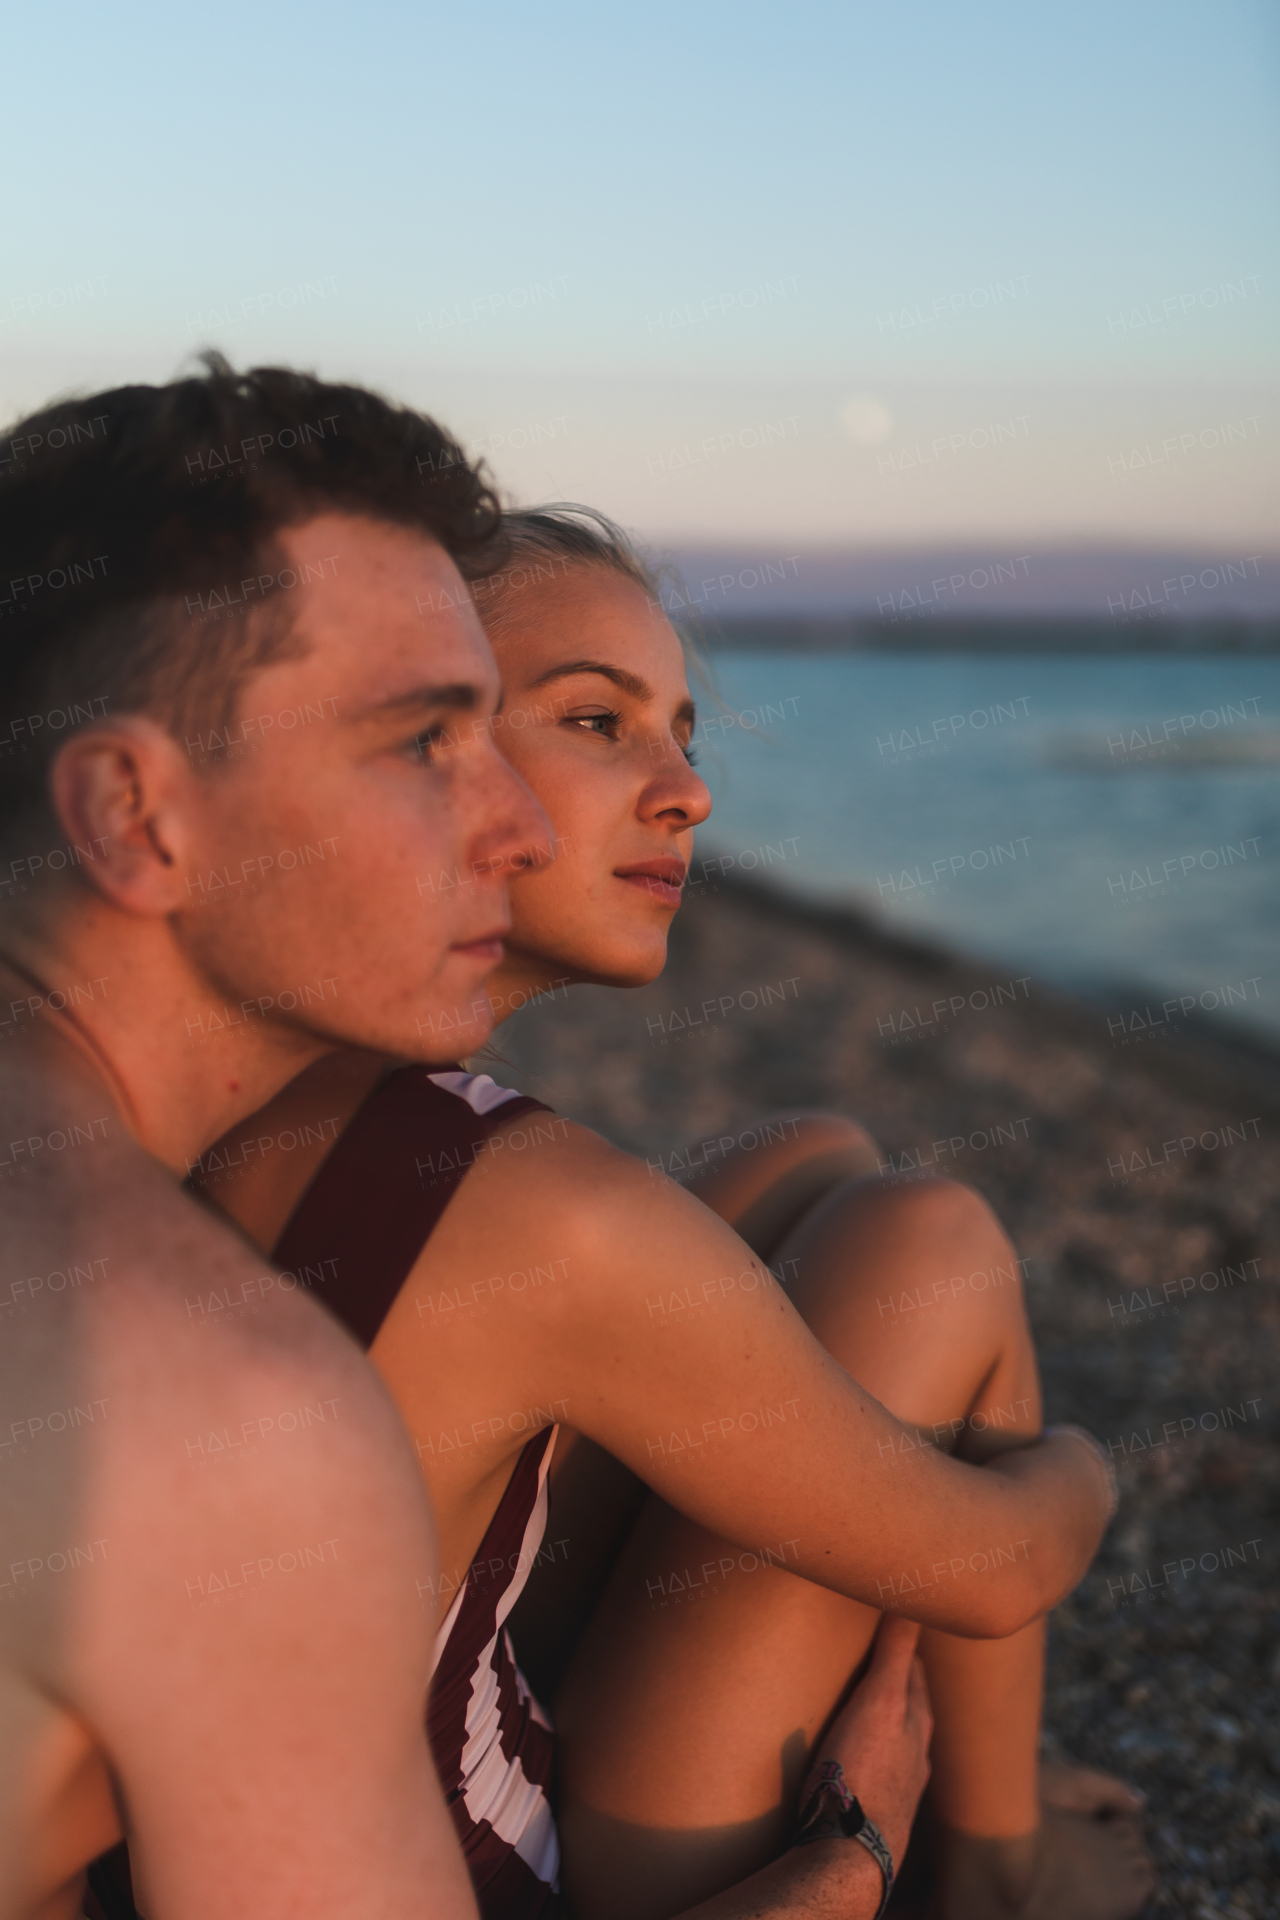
left=50, top=714, right=198, bottom=916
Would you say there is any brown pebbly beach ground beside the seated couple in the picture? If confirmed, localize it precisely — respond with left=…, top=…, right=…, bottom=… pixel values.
left=497, top=887, right=1280, bottom=1920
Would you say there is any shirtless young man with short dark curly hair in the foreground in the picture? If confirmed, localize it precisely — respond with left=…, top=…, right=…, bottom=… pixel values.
left=0, top=363, right=545, bottom=1920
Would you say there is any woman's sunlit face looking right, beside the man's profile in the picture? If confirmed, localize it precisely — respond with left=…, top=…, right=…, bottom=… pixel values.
left=489, top=564, right=712, bottom=1020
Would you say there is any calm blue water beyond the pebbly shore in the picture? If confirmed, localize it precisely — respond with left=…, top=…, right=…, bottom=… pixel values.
left=695, top=653, right=1280, bottom=1039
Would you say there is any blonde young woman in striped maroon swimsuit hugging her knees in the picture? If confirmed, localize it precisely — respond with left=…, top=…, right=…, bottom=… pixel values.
left=192, top=513, right=1150, bottom=1920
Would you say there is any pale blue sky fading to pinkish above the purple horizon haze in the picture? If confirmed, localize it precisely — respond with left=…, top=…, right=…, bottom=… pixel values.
left=0, top=0, right=1280, bottom=541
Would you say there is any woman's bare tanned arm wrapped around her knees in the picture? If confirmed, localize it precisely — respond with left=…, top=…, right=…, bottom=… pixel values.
left=454, top=1123, right=1111, bottom=1638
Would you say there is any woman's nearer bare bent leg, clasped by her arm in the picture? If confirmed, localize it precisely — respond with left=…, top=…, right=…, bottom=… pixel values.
left=557, top=1121, right=1144, bottom=1920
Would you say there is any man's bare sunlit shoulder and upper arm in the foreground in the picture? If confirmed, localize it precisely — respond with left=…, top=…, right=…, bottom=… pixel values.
left=0, top=1156, right=438, bottom=1912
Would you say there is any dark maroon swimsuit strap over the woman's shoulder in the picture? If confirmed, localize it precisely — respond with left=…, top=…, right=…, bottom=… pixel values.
left=273, top=1066, right=549, bottom=1348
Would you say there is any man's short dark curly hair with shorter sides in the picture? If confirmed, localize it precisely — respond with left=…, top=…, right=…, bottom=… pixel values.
left=0, top=353, right=505, bottom=829
